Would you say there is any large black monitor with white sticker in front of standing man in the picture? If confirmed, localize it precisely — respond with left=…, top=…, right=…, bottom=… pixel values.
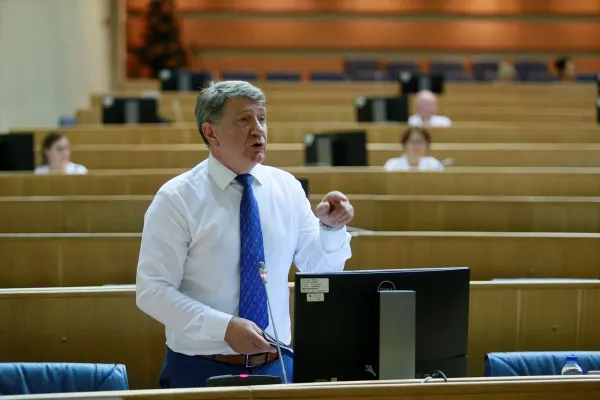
left=294, top=267, right=470, bottom=383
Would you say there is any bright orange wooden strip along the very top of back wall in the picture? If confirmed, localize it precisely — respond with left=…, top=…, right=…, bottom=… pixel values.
left=127, top=0, right=600, bottom=16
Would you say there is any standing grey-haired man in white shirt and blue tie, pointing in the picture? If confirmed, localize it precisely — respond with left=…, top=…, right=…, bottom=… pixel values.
left=136, top=81, right=354, bottom=388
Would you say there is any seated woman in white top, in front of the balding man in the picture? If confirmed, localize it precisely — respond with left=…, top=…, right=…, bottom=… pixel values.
left=383, top=126, right=444, bottom=171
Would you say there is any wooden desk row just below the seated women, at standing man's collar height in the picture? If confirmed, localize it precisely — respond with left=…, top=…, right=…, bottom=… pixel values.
left=0, top=167, right=600, bottom=197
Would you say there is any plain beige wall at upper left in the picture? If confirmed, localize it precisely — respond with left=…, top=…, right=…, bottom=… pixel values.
left=0, top=0, right=111, bottom=130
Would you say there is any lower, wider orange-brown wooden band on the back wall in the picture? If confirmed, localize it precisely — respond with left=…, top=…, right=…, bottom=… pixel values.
left=173, top=18, right=600, bottom=52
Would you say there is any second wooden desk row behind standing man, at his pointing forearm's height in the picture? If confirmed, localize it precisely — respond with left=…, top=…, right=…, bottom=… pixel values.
left=0, top=231, right=600, bottom=288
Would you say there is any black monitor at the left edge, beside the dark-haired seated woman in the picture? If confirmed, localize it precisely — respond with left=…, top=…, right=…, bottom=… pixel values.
left=0, top=133, right=35, bottom=172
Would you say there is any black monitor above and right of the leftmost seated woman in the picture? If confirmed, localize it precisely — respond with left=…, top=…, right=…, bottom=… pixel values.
left=102, top=97, right=160, bottom=124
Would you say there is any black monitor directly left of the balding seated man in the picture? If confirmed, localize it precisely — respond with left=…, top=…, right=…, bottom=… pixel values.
left=355, top=95, right=409, bottom=122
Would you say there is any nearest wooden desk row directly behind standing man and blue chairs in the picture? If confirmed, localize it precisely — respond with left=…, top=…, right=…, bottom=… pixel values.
left=0, top=282, right=600, bottom=390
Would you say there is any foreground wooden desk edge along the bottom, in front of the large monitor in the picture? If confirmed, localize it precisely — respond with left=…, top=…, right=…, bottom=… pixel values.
left=4, top=376, right=600, bottom=400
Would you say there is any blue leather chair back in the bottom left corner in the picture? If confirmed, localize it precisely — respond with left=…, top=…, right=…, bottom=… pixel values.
left=0, top=363, right=129, bottom=396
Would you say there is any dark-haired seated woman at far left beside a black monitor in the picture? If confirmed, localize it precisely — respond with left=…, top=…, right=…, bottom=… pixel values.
left=35, top=132, right=88, bottom=175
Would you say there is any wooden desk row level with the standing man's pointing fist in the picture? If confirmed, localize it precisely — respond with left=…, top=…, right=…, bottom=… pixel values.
left=0, top=194, right=600, bottom=233
